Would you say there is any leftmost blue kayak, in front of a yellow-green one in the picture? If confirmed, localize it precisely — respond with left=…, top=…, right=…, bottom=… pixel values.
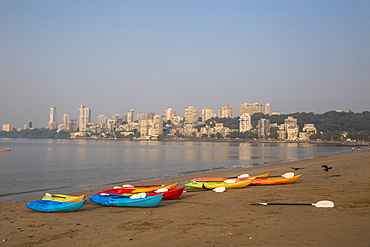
left=26, top=200, right=86, bottom=213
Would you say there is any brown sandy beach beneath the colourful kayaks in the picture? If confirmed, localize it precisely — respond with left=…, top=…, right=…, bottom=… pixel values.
left=0, top=151, right=370, bottom=247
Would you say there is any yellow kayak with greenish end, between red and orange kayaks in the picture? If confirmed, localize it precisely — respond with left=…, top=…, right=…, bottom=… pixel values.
left=185, top=179, right=253, bottom=189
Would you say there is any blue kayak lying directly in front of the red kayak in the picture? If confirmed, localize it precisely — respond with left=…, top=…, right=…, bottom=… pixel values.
left=90, top=194, right=163, bottom=208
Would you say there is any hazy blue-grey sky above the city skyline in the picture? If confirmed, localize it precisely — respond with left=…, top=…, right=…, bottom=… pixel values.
left=0, top=0, right=370, bottom=127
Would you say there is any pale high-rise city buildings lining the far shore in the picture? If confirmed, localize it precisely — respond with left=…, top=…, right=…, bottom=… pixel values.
left=2, top=103, right=317, bottom=141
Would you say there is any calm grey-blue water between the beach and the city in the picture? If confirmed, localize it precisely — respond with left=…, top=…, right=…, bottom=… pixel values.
left=0, top=139, right=358, bottom=202
